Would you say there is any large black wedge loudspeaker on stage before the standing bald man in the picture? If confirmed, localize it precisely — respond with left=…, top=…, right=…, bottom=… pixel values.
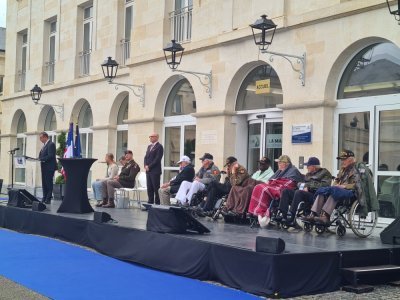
left=146, top=205, right=210, bottom=234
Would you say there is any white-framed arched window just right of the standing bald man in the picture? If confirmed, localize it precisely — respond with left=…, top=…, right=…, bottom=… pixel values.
left=164, top=79, right=196, bottom=180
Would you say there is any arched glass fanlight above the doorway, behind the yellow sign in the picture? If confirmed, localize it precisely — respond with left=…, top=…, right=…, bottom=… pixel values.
left=236, top=64, right=283, bottom=111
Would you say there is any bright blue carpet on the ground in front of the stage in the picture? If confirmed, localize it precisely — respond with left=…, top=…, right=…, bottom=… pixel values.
left=0, top=229, right=256, bottom=299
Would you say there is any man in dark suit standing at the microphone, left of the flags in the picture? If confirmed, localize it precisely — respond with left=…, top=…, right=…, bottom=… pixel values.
left=39, top=132, right=57, bottom=204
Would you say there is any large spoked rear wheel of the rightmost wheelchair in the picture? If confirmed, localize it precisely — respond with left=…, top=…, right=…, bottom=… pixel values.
left=349, top=201, right=378, bottom=238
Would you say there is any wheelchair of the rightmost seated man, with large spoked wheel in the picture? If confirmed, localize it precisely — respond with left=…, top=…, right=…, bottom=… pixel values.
left=303, top=199, right=378, bottom=238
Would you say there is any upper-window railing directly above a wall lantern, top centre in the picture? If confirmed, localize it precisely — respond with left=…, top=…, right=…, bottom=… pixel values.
left=169, top=6, right=193, bottom=43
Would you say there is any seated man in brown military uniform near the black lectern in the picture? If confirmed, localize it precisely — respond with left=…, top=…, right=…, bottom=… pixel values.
left=96, top=150, right=140, bottom=208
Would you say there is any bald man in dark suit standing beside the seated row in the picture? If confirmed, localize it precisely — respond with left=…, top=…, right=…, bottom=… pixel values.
left=144, top=133, right=164, bottom=204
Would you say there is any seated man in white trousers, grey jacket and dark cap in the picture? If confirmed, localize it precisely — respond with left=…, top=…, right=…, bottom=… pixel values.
left=175, top=153, right=221, bottom=205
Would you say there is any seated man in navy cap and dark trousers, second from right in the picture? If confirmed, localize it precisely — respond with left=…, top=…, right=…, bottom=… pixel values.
left=275, top=157, right=332, bottom=224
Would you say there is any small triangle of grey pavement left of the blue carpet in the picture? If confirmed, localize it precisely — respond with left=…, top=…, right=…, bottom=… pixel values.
left=0, top=276, right=49, bottom=300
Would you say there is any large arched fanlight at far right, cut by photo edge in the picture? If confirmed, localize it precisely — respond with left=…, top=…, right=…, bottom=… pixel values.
left=337, top=43, right=400, bottom=99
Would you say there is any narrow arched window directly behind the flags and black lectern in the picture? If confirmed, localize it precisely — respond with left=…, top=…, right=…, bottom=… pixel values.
left=78, top=102, right=93, bottom=158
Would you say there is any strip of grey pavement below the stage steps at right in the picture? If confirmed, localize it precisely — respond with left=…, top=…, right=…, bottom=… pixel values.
left=291, top=285, right=400, bottom=300
